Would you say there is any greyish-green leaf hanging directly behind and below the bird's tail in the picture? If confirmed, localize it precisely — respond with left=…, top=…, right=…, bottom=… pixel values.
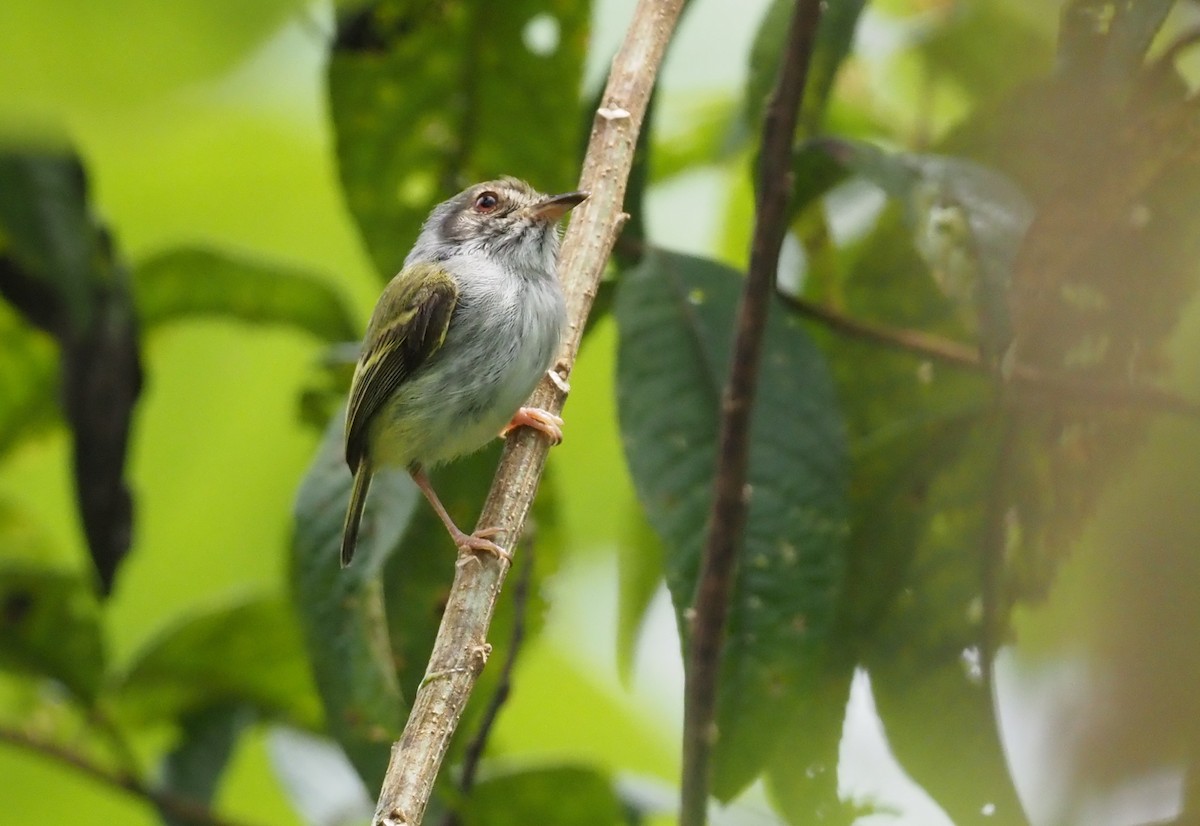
left=290, top=412, right=419, bottom=789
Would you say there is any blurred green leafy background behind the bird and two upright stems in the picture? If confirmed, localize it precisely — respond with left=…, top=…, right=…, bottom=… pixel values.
left=0, top=0, right=1200, bottom=826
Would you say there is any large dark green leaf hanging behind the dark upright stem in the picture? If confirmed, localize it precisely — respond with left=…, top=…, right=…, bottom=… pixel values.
left=617, top=252, right=847, bottom=800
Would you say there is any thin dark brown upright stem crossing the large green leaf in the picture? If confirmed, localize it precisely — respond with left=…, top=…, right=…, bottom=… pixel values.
left=679, top=0, right=821, bottom=826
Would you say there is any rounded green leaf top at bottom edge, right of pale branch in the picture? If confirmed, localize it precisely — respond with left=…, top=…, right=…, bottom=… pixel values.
left=460, top=766, right=628, bottom=826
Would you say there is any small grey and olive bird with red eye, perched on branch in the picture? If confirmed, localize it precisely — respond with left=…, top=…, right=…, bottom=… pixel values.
left=342, top=178, right=588, bottom=567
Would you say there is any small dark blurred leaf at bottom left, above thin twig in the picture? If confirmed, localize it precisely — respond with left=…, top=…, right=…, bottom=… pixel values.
left=160, top=705, right=254, bottom=826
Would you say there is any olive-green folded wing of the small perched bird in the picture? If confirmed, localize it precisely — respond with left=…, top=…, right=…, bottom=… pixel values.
left=346, top=263, right=458, bottom=471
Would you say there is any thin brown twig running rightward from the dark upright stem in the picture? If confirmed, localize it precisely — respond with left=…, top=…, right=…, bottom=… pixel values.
left=778, top=292, right=1200, bottom=418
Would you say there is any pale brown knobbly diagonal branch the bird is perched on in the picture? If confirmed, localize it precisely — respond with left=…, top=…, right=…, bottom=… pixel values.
left=364, top=0, right=683, bottom=826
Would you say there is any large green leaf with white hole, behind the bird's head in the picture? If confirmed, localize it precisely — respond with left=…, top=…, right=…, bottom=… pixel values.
left=329, top=0, right=590, bottom=276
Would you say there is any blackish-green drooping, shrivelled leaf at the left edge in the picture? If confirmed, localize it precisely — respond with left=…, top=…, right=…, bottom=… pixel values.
left=0, top=152, right=142, bottom=593
